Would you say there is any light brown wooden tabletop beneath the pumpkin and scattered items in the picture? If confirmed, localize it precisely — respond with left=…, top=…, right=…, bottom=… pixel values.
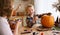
left=18, top=24, right=60, bottom=35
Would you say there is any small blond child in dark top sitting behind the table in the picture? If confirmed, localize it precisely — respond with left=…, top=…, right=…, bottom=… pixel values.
left=26, top=5, right=35, bottom=28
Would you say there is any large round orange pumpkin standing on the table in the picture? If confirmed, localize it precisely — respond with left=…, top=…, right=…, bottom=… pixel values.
left=41, top=15, right=54, bottom=28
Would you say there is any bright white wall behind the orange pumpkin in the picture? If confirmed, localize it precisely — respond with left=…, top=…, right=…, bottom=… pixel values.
left=34, top=0, right=59, bottom=21
